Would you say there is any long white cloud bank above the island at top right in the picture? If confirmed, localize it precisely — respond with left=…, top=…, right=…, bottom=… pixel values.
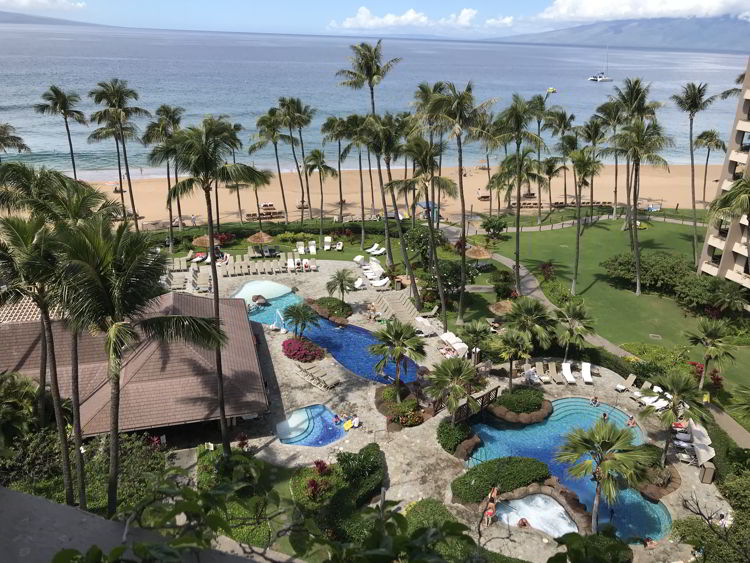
left=539, top=0, right=750, bottom=21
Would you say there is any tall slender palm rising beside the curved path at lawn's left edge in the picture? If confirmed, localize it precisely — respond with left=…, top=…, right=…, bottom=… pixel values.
left=498, top=94, right=543, bottom=294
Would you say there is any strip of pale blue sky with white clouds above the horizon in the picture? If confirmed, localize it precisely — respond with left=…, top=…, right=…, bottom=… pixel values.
left=0, top=0, right=750, bottom=38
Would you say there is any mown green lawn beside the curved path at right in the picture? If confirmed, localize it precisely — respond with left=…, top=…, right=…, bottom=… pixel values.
left=482, top=221, right=750, bottom=383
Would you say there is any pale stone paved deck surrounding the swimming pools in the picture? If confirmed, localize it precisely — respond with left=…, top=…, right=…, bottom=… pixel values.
left=203, top=262, right=729, bottom=562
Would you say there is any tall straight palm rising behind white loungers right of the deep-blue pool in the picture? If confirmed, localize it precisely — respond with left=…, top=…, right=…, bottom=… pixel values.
left=428, top=81, right=492, bottom=324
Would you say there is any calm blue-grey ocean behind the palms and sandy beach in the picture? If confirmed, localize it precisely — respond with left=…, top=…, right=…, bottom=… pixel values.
left=0, top=24, right=747, bottom=180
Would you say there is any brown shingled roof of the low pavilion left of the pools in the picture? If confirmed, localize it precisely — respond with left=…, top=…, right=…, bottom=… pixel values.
left=0, top=293, right=268, bottom=436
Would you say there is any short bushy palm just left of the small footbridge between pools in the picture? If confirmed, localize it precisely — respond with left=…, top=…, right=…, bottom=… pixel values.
left=424, top=358, right=479, bottom=425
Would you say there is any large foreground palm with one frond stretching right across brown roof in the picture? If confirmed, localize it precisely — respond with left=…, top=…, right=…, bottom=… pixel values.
left=63, top=219, right=226, bottom=517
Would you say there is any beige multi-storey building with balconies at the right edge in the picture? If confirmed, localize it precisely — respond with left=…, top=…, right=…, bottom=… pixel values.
left=699, top=59, right=750, bottom=288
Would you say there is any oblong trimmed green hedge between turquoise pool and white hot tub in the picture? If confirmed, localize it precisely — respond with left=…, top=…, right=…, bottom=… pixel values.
left=451, top=457, right=549, bottom=502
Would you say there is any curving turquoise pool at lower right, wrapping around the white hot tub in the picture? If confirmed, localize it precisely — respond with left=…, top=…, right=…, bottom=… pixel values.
left=469, top=398, right=672, bottom=540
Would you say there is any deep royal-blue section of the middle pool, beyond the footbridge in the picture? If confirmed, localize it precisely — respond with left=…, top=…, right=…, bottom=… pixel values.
left=305, top=318, right=424, bottom=383
